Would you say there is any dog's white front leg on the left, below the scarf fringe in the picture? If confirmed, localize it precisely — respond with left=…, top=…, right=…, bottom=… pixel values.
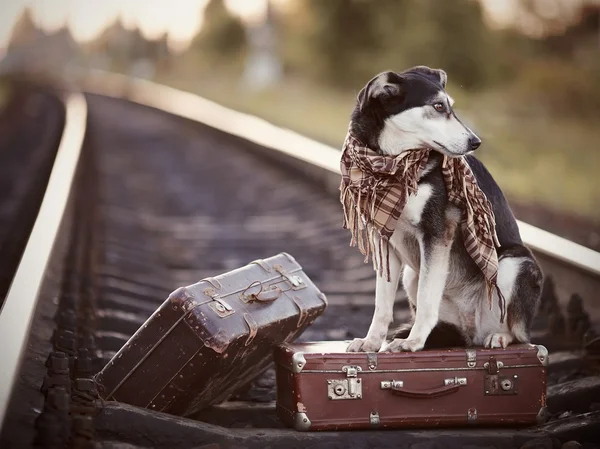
left=347, top=233, right=402, bottom=352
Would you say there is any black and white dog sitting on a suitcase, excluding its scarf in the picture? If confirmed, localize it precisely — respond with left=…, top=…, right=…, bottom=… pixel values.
left=347, top=66, right=542, bottom=352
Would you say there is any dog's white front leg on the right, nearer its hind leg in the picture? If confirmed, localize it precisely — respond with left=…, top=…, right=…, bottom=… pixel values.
left=381, top=242, right=452, bottom=352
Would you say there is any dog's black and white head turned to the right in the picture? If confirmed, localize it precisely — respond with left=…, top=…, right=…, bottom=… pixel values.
left=350, top=66, right=481, bottom=157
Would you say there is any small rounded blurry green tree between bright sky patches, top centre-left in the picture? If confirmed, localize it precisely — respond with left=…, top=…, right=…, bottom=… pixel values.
left=190, top=0, right=246, bottom=63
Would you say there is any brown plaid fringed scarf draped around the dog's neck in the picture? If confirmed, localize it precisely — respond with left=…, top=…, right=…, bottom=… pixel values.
left=340, top=133, right=506, bottom=323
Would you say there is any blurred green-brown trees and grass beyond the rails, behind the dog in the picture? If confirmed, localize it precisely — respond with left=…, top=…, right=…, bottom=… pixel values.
left=5, top=0, right=600, bottom=224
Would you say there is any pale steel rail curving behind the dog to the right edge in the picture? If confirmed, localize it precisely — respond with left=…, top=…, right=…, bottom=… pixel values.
left=75, top=70, right=600, bottom=279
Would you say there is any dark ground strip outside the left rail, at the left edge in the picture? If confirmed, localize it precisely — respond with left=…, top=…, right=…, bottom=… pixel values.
left=0, top=82, right=65, bottom=307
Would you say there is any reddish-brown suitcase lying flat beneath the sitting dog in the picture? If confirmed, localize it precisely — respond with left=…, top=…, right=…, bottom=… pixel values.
left=274, top=341, right=548, bottom=430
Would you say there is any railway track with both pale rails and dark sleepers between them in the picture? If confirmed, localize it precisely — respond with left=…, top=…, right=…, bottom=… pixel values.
left=0, top=75, right=600, bottom=448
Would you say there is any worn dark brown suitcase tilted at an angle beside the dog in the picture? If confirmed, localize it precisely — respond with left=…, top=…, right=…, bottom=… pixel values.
left=95, top=253, right=327, bottom=416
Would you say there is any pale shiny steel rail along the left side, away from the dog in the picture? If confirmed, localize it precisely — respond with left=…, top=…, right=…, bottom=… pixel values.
left=0, top=93, right=87, bottom=427
